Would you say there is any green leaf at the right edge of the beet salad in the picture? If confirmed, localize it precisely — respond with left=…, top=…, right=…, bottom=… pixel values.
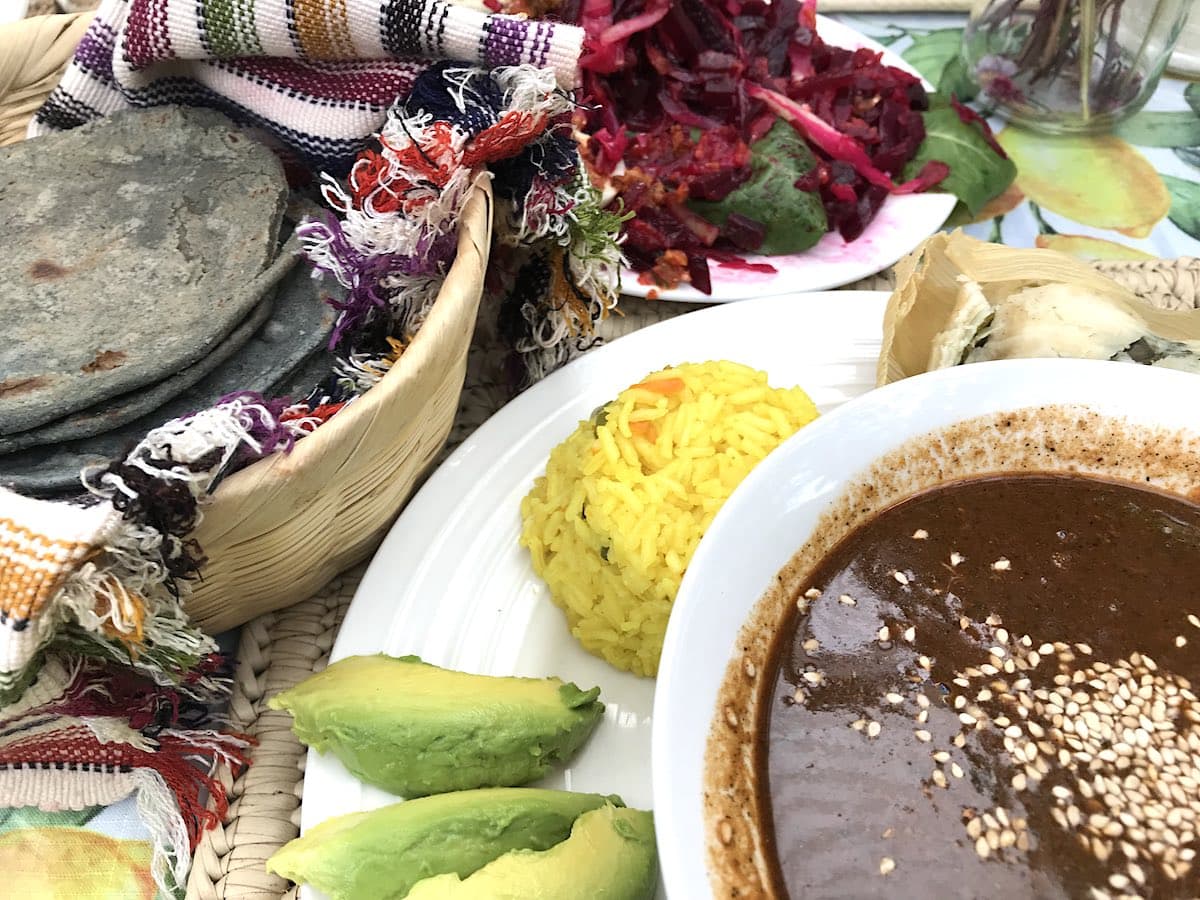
left=904, top=95, right=1016, bottom=216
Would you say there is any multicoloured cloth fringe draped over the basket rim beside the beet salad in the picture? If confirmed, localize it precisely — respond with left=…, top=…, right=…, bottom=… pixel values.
left=298, top=64, right=623, bottom=382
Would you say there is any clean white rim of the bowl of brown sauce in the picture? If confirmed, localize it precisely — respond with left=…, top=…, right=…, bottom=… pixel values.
left=652, top=360, right=1200, bottom=900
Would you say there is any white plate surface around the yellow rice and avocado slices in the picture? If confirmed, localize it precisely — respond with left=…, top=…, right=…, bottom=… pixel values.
left=301, top=290, right=888, bottom=896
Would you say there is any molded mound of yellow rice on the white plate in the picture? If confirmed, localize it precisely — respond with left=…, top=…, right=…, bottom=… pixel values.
left=521, top=361, right=817, bottom=676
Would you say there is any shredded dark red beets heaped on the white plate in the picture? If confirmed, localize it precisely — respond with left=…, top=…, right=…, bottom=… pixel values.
left=564, top=0, right=945, bottom=292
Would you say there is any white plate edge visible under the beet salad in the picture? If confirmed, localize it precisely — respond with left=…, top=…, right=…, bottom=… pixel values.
left=620, top=16, right=958, bottom=304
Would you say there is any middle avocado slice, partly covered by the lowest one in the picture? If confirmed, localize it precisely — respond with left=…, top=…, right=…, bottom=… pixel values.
left=266, top=787, right=622, bottom=900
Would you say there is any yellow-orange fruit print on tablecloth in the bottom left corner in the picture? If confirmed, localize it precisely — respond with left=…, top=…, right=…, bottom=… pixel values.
left=0, top=827, right=156, bottom=900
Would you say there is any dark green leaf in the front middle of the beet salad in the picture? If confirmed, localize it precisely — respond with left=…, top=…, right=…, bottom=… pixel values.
left=688, top=120, right=829, bottom=256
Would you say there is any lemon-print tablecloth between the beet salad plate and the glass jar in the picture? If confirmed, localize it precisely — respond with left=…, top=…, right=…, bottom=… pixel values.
left=835, top=14, right=1200, bottom=259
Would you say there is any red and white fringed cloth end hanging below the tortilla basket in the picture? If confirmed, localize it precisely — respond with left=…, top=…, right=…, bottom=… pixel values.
left=0, top=656, right=251, bottom=896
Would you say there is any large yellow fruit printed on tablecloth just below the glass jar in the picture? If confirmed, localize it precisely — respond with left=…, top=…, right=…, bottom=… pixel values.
left=997, top=127, right=1171, bottom=238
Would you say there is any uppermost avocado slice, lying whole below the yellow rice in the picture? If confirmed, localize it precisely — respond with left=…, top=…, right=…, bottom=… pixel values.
left=269, top=654, right=604, bottom=797
